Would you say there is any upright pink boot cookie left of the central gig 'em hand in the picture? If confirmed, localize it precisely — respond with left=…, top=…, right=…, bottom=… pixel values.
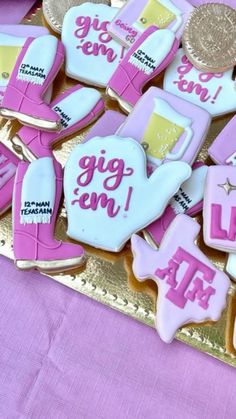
left=13, top=157, right=84, bottom=273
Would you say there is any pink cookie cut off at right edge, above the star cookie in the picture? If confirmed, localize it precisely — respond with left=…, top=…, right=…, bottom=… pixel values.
left=208, top=116, right=236, bottom=166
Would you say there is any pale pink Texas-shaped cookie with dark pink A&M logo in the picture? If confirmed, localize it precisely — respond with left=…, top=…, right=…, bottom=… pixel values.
left=131, top=214, right=230, bottom=343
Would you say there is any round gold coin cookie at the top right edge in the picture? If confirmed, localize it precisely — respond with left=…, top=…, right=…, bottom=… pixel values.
left=182, top=3, right=236, bottom=73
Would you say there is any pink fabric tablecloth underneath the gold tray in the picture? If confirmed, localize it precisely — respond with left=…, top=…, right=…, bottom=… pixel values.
left=0, top=0, right=236, bottom=419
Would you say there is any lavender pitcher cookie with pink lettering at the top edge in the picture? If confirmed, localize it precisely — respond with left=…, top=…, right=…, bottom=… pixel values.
left=109, top=0, right=193, bottom=47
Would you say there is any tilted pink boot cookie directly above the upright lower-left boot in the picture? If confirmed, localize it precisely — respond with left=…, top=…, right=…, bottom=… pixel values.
left=12, top=84, right=104, bottom=161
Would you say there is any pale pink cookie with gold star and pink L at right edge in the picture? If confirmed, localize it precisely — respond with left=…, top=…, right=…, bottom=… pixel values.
left=203, top=166, right=236, bottom=252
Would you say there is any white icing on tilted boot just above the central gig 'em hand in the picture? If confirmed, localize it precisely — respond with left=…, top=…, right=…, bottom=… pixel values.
left=52, top=87, right=101, bottom=128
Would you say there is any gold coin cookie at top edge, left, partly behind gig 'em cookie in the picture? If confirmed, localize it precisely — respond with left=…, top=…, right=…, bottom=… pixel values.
left=43, top=0, right=111, bottom=33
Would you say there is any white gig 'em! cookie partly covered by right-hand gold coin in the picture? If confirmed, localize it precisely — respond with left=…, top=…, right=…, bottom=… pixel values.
left=164, top=49, right=236, bottom=117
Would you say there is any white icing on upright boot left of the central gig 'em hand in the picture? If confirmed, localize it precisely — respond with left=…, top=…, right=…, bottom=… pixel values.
left=20, top=157, right=56, bottom=224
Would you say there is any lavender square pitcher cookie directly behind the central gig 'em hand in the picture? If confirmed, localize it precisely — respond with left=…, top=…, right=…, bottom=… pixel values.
left=117, top=87, right=211, bottom=171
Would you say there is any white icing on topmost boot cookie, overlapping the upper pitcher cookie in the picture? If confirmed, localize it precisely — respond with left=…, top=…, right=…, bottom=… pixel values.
left=129, top=29, right=175, bottom=75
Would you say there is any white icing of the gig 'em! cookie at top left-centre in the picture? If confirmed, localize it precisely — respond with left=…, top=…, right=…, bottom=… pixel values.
left=62, top=3, right=124, bottom=87
